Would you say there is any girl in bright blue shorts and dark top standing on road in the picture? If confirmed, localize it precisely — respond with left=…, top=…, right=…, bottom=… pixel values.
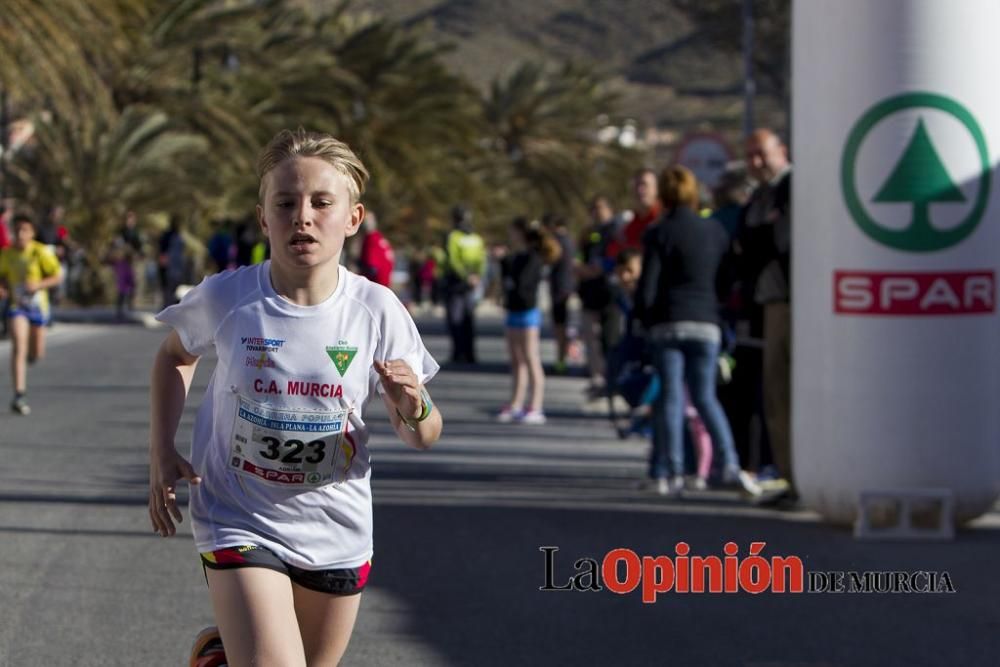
left=497, top=218, right=561, bottom=424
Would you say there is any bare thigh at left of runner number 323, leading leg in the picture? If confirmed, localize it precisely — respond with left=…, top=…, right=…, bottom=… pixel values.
left=205, top=567, right=306, bottom=667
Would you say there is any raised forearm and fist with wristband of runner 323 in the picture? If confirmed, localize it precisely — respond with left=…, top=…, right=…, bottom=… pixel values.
left=375, top=359, right=444, bottom=449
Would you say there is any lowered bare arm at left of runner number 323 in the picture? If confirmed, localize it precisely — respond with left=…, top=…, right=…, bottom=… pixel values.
left=149, top=331, right=201, bottom=537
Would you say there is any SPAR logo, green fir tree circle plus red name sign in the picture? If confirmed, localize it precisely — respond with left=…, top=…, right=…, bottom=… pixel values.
left=833, top=92, right=996, bottom=316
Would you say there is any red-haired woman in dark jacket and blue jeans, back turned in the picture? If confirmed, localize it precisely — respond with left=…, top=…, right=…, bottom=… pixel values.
left=635, top=166, right=759, bottom=495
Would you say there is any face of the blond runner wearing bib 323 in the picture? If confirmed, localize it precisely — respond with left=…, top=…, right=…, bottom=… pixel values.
left=257, top=157, right=365, bottom=276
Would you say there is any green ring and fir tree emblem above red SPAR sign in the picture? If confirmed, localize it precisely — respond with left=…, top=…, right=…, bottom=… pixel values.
left=841, top=93, right=990, bottom=252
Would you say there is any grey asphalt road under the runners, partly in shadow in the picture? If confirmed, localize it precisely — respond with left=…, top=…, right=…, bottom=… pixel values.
left=0, top=314, right=1000, bottom=667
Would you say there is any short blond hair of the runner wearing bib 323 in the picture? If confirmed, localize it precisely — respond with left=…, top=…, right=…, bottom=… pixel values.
left=257, top=127, right=368, bottom=204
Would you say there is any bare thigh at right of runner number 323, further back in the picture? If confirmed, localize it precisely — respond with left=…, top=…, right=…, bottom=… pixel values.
left=292, top=584, right=361, bottom=667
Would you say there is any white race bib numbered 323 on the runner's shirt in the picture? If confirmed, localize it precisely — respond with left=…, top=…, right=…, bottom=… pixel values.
left=229, top=396, right=348, bottom=488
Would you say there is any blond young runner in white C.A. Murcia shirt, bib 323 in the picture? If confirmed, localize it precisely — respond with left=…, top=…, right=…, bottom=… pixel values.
left=149, top=129, right=442, bottom=666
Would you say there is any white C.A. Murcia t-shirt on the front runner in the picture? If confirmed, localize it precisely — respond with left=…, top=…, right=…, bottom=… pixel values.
left=157, top=261, right=438, bottom=570
